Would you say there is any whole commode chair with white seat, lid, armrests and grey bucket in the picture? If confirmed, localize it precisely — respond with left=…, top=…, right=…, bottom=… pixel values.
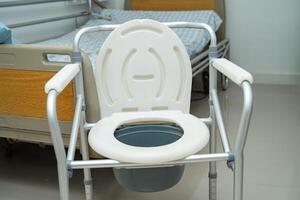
left=45, top=20, right=253, bottom=200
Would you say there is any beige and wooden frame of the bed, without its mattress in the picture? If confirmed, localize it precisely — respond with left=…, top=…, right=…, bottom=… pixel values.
left=0, top=0, right=228, bottom=155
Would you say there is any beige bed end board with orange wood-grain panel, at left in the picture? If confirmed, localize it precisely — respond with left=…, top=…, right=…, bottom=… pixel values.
left=0, top=44, right=74, bottom=124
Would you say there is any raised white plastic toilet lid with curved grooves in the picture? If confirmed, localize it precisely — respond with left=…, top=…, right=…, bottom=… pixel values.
left=95, top=20, right=192, bottom=117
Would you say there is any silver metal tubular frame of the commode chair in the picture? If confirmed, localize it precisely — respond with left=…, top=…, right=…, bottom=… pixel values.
left=47, top=22, right=253, bottom=200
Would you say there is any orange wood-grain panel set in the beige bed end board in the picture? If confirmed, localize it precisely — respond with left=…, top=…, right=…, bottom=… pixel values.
left=0, top=69, right=74, bottom=121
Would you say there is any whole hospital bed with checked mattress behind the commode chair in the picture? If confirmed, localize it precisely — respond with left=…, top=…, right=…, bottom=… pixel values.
left=0, top=0, right=229, bottom=153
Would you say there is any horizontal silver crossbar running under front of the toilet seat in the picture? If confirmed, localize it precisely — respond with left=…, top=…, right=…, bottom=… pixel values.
left=71, top=153, right=229, bottom=169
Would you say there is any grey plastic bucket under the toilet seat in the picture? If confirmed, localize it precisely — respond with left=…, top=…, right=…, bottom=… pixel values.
left=113, top=124, right=184, bottom=192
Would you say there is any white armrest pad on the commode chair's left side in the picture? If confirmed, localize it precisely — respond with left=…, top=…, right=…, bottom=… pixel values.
left=45, top=63, right=80, bottom=93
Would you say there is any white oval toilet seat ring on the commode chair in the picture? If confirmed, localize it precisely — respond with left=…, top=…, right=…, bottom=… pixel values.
left=89, top=111, right=209, bottom=163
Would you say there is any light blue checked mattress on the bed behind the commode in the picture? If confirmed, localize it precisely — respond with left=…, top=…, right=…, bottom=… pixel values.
left=36, top=9, right=222, bottom=66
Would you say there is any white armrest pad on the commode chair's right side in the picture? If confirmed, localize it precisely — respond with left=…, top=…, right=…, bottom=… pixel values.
left=212, top=58, right=253, bottom=86
